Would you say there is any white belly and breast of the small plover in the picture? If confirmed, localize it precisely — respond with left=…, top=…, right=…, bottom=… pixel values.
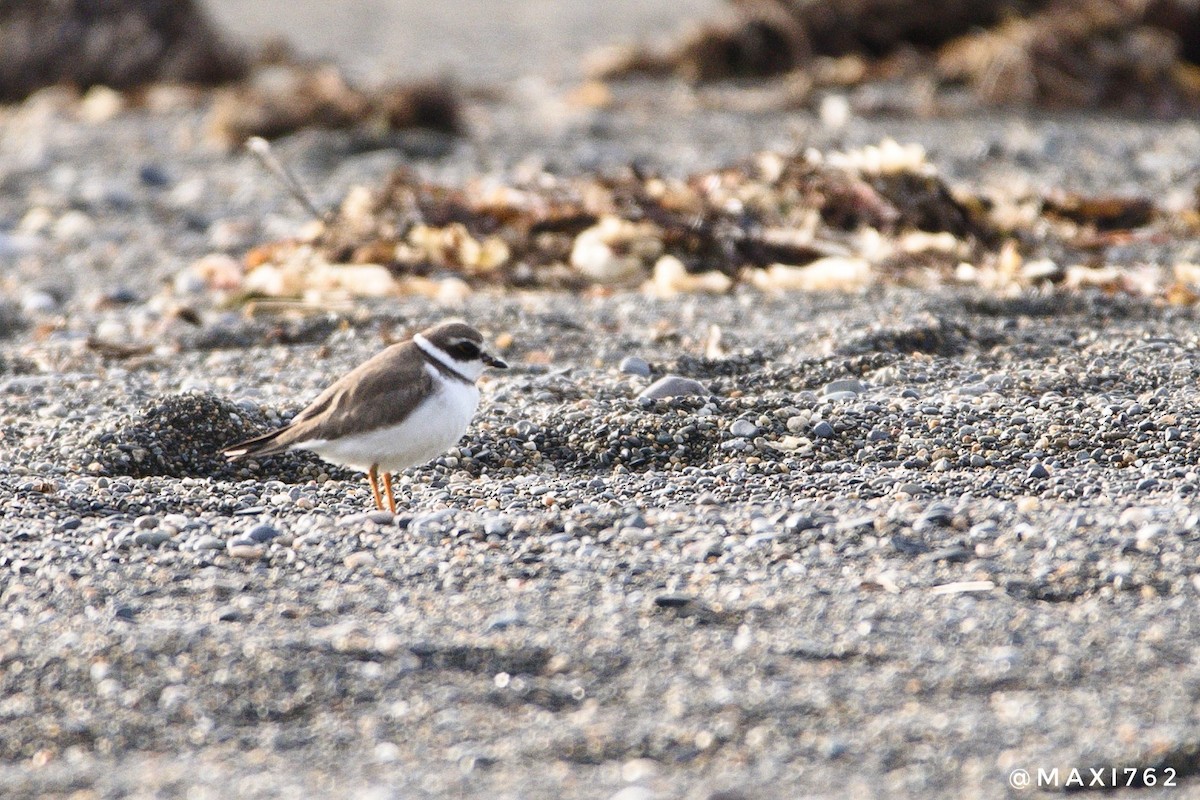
left=295, top=381, right=479, bottom=473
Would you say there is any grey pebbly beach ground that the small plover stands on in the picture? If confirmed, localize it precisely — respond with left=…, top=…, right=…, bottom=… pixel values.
left=0, top=0, right=1200, bottom=800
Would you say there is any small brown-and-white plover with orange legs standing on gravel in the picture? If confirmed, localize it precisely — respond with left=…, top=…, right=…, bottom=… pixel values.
left=224, top=321, right=509, bottom=513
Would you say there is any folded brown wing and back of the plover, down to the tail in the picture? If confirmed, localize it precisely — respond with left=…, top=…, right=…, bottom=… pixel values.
left=224, top=342, right=433, bottom=458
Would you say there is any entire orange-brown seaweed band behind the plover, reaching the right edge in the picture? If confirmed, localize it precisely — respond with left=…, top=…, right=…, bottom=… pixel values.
left=218, top=140, right=1200, bottom=302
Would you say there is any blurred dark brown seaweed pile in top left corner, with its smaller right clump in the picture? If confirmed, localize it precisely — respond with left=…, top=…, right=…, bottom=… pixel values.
left=0, top=0, right=464, bottom=148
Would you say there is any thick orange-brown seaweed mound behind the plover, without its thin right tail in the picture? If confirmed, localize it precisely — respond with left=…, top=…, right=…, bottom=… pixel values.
left=229, top=143, right=997, bottom=295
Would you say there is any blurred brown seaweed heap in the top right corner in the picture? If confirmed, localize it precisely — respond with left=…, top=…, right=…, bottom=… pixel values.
left=598, top=0, right=1200, bottom=114
